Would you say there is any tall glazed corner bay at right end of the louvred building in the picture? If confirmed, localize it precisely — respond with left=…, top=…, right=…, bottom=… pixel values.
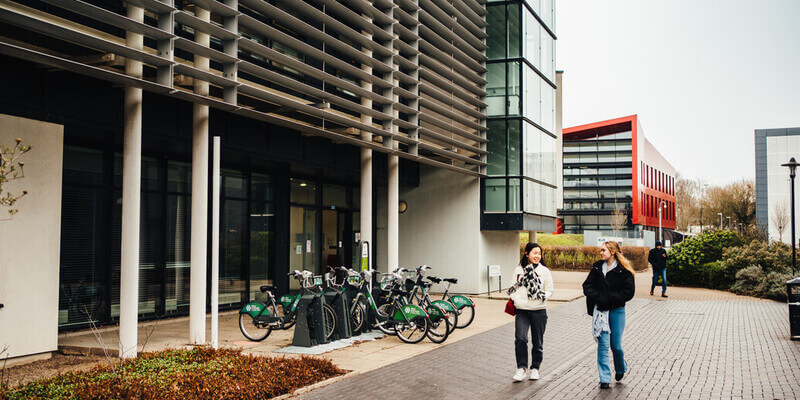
left=483, top=0, right=558, bottom=217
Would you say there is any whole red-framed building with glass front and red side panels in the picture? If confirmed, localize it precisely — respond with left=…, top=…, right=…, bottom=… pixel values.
left=559, top=115, right=676, bottom=237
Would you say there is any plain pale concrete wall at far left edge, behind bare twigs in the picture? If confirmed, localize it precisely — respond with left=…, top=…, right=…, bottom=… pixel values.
left=0, top=115, right=64, bottom=358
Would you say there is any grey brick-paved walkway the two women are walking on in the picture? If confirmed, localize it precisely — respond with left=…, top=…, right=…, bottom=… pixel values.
left=302, top=292, right=800, bottom=400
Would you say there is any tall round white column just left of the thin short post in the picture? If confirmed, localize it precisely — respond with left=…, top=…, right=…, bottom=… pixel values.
left=189, top=7, right=211, bottom=345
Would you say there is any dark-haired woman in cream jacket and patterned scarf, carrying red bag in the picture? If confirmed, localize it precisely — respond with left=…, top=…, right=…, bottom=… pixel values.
left=508, top=243, right=553, bottom=382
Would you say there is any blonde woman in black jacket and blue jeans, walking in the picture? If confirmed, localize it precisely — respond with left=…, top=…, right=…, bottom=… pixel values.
left=583, top=241, right=636, bottom=389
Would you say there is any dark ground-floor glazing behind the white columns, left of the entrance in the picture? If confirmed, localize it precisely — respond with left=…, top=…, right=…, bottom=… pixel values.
left=58, top=146, right=275, bottom=329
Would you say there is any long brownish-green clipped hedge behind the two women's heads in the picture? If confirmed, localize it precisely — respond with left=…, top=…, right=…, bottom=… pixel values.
left=542, top=246, right=650, bottom=271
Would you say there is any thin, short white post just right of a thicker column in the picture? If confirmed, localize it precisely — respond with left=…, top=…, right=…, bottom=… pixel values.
left=211, top=136, right=221, bottom=349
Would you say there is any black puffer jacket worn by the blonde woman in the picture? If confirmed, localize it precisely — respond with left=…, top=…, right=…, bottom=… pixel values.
left=583, top=260, right=636, bottom=315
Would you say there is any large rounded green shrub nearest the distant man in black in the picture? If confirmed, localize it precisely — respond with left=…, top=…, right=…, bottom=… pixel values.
left=667, top=230, right=742, bottom=287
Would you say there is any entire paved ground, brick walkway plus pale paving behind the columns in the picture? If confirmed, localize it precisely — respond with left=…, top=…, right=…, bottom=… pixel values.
left=59, top=271, right=800, bottom=400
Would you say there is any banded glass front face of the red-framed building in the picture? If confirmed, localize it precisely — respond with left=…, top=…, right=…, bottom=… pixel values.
left=562, top=131, right=633, bottom=233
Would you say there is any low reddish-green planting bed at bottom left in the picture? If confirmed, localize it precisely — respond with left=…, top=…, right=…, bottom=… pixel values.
left=0, top=348, right=344, bottom=400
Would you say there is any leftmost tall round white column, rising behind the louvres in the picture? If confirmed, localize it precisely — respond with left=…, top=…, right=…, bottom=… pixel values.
left=119, top=5, right=144, bottom=358
